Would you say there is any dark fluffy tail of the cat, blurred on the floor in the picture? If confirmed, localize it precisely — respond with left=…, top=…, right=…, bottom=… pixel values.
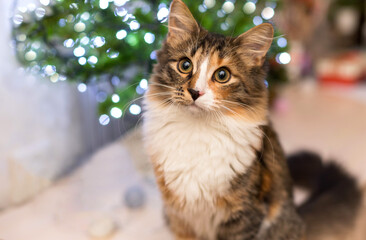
left=288, top=152, right=362, bottom=240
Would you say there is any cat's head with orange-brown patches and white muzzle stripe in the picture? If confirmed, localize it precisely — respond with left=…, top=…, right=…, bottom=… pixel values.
left=147, top=0, right=273, bottom=122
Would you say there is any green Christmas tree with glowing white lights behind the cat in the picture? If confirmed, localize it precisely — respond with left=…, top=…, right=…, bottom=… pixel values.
left=12, top=0, right=290, bottom=124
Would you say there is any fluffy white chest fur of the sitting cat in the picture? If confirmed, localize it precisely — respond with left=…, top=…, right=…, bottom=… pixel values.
left=144, top=106, right=261, bottom=203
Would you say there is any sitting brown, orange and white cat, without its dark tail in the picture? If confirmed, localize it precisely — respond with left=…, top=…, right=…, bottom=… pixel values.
left=143, top=0, right=362, bottom=240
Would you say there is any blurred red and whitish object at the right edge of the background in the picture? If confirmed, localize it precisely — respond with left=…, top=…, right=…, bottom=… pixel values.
left=317, top=51, right=366, bottom=85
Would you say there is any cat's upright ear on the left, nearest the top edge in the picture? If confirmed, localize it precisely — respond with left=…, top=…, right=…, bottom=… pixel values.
left=167, top=0, right=200, bottom=42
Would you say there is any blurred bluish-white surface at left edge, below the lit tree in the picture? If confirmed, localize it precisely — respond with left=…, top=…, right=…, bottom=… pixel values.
left=0, top=0, right=85, bottom=208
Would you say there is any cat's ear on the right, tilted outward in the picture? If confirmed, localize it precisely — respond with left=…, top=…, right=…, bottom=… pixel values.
left=236, top=23, right=273, bottom=66
